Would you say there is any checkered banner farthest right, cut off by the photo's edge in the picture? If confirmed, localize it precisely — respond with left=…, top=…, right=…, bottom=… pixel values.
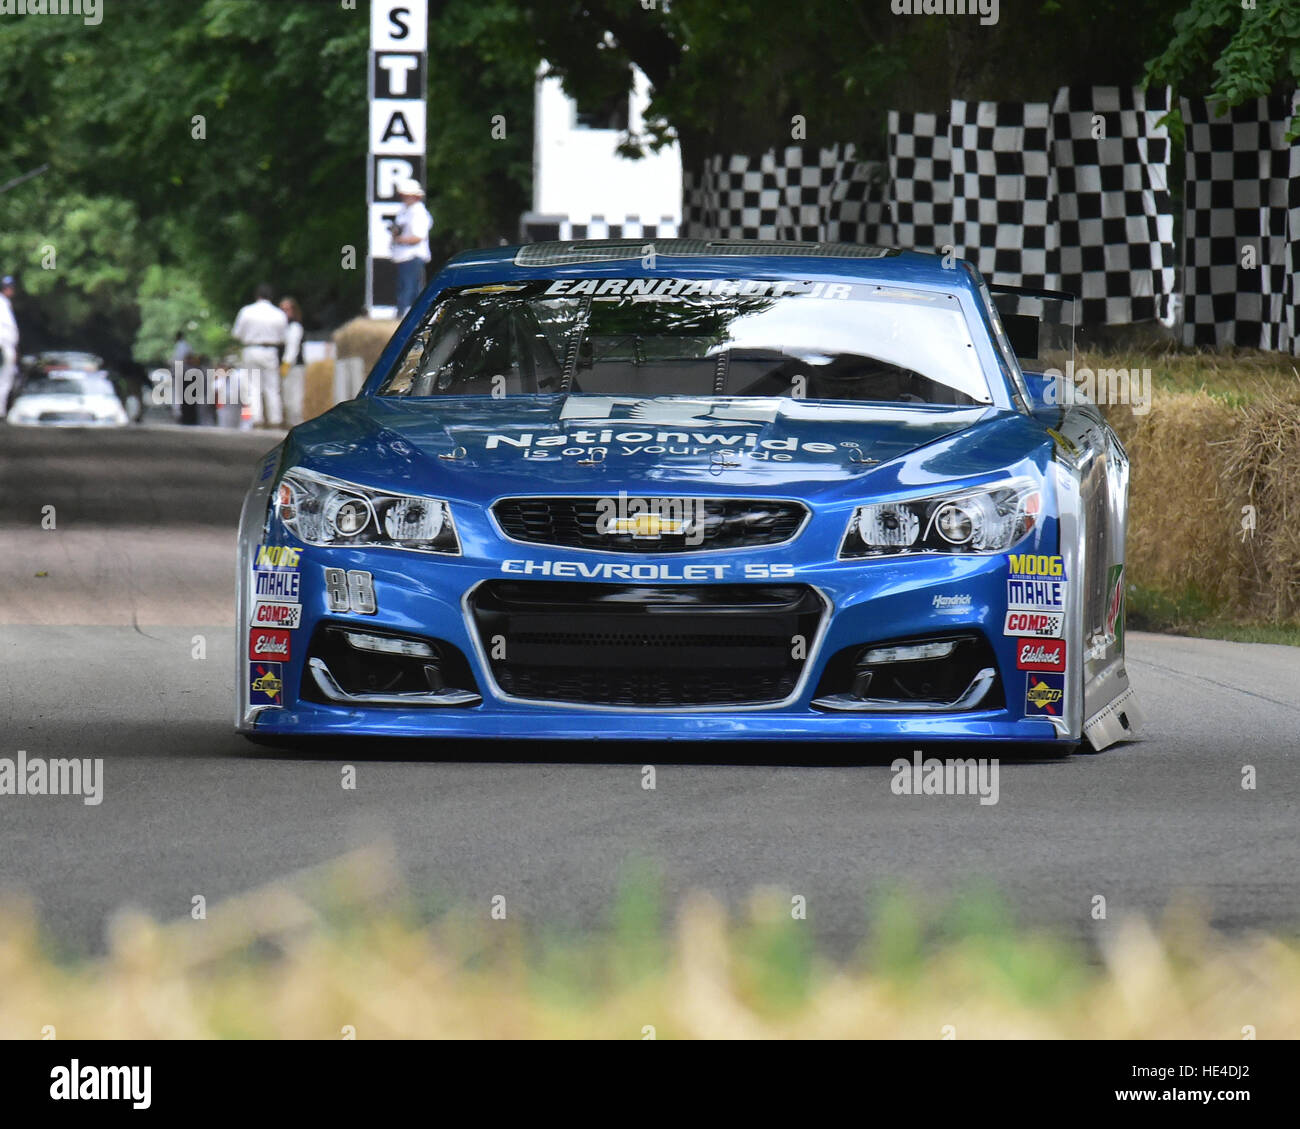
left=1182, top=98, right=1300, bottom=352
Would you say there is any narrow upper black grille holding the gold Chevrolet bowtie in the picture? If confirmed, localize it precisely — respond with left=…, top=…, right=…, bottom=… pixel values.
left=493, top=498, right=807, bottom=553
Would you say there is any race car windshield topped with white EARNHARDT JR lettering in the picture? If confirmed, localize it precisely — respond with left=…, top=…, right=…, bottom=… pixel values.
left=378, top=278, right=992, bottom=407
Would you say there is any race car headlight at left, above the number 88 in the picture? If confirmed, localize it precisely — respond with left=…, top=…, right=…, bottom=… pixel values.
left=272, top=467, right=460, bottom=555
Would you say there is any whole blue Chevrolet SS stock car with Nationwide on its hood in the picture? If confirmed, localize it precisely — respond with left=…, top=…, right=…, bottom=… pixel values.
left=237, top=239, right=1139, bottom=749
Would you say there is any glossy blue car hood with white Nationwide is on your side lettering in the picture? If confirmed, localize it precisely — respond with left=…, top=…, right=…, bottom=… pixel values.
left=289, top=395, right=1045, bottom=499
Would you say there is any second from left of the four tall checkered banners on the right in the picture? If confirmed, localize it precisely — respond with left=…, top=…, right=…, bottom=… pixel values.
left=948, top=101, right=1061, bottom=290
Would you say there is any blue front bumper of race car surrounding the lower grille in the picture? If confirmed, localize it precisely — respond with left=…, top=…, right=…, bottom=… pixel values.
left=238, top=523, right=1082, bottom=743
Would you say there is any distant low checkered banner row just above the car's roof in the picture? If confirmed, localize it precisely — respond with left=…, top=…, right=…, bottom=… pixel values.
left=683, top=144, right=888, bottom=245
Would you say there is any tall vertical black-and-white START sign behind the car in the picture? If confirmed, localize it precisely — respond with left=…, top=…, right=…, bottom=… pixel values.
left=365, top=0, right=429, bottom=316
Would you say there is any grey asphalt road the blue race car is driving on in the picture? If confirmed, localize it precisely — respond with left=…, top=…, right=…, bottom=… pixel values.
left=0, top=425, right=1300, bottom=951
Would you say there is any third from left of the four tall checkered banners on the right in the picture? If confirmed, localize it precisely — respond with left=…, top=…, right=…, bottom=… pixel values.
left=1052, top=86, right=1175, bottom=325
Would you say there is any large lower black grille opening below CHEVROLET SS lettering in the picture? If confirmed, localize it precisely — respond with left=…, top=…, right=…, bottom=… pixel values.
left=469, top=580, right=824, bottom=709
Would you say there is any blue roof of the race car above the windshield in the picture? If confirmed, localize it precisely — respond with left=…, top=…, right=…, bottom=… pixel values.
left=442, top=238, right=972, bottom=290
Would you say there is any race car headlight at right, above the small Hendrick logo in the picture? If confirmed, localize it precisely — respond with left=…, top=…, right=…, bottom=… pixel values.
left=840, top=481, right=1043, bottom=559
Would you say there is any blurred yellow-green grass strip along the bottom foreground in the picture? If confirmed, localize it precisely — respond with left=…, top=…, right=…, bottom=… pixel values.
left=0, top=849, right=1300, bottom=1039
